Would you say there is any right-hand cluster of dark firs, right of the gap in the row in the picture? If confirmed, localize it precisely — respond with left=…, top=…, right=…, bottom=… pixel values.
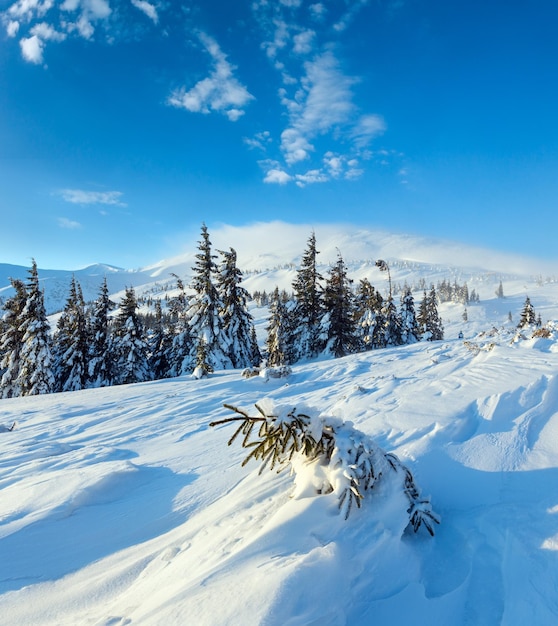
left=265, top=234, right=444, bottom=366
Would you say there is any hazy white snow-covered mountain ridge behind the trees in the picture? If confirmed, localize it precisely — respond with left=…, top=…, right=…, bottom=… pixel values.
left=0, top=222, right=558, bottom=313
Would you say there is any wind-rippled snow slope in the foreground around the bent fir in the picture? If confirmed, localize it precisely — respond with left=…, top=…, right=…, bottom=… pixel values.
left=0, top=332, right=558, bottom=626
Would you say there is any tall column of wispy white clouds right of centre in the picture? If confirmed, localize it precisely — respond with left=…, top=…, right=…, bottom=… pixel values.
left=251, top=0, right=387, bottom=187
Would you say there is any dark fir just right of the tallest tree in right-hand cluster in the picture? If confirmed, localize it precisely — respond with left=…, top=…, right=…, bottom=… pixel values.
left=322, top=253, right=361, bottom=358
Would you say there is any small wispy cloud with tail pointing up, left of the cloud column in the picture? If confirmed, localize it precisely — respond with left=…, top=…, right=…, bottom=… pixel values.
left=168, top=33, right=254, bottom=122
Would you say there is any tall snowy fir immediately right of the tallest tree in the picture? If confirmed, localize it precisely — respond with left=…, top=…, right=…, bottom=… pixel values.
left=217, top=248, right=261, bottom=368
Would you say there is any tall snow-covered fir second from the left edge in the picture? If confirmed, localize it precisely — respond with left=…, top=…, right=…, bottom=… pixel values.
left=16, top=259, right=55, bottom=396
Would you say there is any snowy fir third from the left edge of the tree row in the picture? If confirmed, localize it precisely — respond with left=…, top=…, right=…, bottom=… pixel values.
left=53, top=276, right=89, bottom=391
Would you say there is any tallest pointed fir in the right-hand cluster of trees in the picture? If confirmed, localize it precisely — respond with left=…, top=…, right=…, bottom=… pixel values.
left=292, top=233, right=324, bottom=360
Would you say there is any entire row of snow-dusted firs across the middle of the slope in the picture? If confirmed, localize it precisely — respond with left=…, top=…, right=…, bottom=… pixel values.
left=0, top=225, right=444, bottom=398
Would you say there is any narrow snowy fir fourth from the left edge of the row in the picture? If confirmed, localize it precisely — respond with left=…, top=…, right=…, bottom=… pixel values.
left=87, top=277, right=116, bottom=387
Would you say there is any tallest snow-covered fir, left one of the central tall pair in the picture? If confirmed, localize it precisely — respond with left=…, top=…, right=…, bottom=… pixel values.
left=186, top=224, right=233, bottom=374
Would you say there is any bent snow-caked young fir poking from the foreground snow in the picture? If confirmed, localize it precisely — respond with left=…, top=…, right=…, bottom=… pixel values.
left=210, top=404, right=440, bottom=535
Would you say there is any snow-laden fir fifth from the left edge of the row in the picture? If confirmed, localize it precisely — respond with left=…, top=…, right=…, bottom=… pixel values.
left=113, top=287, right=151, bottom=385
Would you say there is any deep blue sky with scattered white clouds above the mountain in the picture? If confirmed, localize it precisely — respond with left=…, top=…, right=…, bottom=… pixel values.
left=0, top=0, right=558, bottom=269
